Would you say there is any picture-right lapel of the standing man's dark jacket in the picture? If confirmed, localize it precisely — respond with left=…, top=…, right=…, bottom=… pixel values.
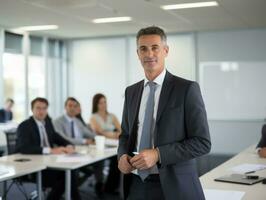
left=156, top=71, right=174, bottom=122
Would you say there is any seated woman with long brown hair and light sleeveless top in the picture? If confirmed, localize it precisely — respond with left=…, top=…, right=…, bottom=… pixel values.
left=90, top=94, right=121, bottom=193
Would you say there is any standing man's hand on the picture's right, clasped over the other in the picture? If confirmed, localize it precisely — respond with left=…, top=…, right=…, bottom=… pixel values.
left=130, top=149, right=159, bottom=170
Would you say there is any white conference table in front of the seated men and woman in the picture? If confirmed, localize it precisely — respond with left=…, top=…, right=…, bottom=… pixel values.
left=0, top=142, right=117, bottom=200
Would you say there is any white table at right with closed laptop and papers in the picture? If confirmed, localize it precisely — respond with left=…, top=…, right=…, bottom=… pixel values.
left=200, top=145, right=266, bottom=200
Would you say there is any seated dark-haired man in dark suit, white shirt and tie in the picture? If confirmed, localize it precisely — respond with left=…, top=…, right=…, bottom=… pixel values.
left=16, top=97, right=80, bottom=200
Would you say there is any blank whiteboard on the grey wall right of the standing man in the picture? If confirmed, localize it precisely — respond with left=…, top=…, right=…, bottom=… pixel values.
left=199, top=62, right=266, bottom=120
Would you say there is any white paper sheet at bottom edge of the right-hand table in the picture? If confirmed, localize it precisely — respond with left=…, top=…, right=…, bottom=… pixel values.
left=203, top=189, right=245, bottom=200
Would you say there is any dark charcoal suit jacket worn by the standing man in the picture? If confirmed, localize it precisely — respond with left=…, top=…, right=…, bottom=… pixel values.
left=118, top=72, right=211, bottom=200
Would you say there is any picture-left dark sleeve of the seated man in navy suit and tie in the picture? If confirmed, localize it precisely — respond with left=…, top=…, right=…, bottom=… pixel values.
left=16, top=124, right=42, bottom=154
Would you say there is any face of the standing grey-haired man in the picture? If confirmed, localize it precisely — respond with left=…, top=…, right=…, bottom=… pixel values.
left=137, top=35, right=169, bottom=73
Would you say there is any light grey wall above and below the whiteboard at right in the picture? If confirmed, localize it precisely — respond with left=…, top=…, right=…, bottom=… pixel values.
left=197, top=29, right=266, bottom=154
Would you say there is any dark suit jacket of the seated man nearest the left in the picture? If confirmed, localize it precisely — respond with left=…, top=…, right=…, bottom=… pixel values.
left=16, top=117, right=69, bottom=154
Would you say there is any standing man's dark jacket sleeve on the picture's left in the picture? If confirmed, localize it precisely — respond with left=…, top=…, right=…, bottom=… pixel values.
left=117, top=90, right=129, bottom=160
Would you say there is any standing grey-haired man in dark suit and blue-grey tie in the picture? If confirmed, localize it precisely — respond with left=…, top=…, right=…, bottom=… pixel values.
left=118, top=26, right=211, bottom=200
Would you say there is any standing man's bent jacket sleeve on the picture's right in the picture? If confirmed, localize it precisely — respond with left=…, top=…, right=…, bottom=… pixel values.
left=158, top=82, right=211, bottom=167
